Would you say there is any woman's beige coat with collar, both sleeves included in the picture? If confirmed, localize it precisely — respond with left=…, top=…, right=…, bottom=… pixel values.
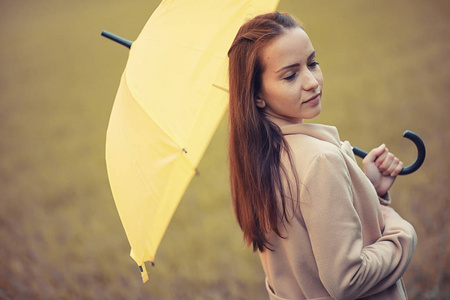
left=260, top=124, right=417, bottom=300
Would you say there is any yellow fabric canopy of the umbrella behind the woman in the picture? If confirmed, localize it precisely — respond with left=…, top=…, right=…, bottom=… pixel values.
left=106, top=0, right=278, bottom=282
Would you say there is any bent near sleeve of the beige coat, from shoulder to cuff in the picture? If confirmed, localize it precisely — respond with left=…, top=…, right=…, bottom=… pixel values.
left=300, top=153, right=416, bottom=299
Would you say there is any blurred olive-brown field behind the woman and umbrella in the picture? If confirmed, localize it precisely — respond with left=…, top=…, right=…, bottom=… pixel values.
left=0, top=0, right=450, bottom=299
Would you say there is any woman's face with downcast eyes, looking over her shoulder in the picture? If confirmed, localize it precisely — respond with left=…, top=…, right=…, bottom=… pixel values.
left=256, top=28, right=323, bottom=123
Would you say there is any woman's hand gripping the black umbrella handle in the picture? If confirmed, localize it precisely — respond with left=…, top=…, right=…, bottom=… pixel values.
left=362, top=144, right=403, bottom=197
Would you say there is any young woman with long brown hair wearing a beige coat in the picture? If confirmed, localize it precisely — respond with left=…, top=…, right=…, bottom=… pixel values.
left=228, top=13, right=417, bottom=299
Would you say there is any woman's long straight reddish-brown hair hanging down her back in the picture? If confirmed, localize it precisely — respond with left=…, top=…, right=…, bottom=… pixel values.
left=228, top=12, right=302, bottom=251
